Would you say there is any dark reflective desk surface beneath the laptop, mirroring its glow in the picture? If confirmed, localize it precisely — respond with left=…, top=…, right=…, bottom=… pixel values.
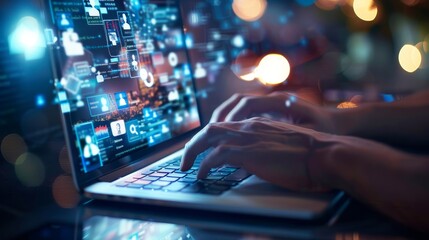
left=0, top=198, right=424, bottom=239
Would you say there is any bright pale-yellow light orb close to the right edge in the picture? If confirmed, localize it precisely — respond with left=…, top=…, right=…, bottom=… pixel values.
left=398, top=44, right=422, bottom=73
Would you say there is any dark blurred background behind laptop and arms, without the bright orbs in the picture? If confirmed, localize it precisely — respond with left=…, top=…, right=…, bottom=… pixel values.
left=0, top=0, right=429, bottom=233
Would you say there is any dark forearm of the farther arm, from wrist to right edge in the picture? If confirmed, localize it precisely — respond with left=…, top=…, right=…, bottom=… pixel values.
left=333, top=102, right=429, bottom=147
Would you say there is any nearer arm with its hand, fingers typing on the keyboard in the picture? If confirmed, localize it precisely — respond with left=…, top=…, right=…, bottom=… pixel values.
left=181, top=118, right=429, bottom=230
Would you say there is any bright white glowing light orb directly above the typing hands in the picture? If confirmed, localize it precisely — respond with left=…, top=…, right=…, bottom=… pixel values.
left=255, top=54, right=290, bottom=85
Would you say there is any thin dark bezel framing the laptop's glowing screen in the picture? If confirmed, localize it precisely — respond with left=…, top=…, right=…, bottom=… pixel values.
left=43, top=0, right=204, bottom=191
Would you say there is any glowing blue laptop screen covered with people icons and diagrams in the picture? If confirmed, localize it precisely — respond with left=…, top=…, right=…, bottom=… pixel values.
left=46, top=0, right=200, bottom=174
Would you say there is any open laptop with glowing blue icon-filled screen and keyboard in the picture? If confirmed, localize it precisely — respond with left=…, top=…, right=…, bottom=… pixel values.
left=45, top=0, right=344, bottom=220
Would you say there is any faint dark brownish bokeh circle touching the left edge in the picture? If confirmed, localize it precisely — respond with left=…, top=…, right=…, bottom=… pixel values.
left=1, top=134, right=27, bottom=164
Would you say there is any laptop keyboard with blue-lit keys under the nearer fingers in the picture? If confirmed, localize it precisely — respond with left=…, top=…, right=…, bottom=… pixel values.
left=115, top=154, right=250, bottom=195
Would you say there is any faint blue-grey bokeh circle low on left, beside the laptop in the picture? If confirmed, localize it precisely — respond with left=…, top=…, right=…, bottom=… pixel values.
left=15, top=153, right=45, bottom=187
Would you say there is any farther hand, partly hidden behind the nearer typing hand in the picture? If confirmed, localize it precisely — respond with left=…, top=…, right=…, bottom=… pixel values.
left=210, top=92, right=336, bottom=133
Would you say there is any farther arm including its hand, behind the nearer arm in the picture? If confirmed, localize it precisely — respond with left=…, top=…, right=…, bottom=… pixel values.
left=211, top=90, right=429, bottom=147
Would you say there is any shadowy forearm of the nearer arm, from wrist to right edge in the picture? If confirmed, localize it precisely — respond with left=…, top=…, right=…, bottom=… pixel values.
left=310, top=138, right=429, bottom=231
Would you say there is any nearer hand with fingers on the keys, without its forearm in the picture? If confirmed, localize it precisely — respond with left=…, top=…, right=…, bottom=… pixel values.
left=181, top=118, right=335, bottom=191
